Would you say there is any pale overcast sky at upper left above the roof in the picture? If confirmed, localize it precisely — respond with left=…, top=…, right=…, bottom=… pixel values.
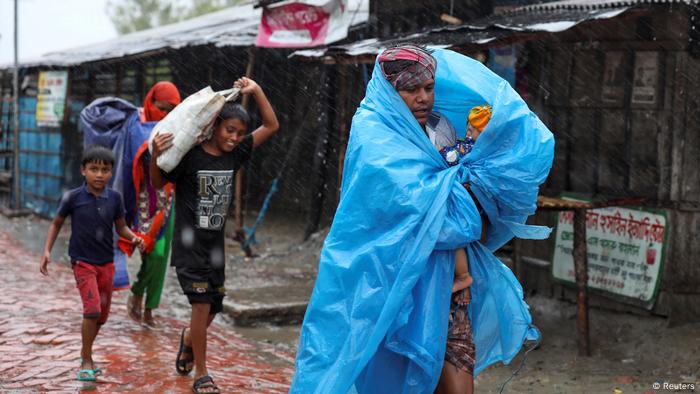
left=0, top=0, right=117, bottom=64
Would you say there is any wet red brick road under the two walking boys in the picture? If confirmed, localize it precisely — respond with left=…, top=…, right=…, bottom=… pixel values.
left=0, top=231, right=293, bottom=393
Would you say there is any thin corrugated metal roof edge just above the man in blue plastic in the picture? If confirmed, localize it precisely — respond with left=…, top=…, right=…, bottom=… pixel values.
left=291, top=7, right=628, bottom=59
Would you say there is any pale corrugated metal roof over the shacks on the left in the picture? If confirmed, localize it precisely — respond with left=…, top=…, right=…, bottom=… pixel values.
left=15, top=0, right=369, bottom=67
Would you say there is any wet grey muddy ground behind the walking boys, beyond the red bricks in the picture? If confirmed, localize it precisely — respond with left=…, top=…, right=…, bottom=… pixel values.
left=0, top=215, right=322, bottom=363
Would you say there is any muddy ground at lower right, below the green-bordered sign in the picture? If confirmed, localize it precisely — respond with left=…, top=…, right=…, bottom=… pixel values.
left=476, top=297, right=700, bottom=393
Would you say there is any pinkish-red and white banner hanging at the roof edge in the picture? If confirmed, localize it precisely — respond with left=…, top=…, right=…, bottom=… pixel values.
left=256, top=0, right=352, bottom=48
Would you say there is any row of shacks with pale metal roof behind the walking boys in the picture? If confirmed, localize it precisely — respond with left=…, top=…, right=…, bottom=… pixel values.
left=0, top=0, right=368, bottom=239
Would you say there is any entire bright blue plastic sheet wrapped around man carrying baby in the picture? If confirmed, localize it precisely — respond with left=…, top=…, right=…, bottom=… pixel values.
left=291, top=50, right=554, bottom=393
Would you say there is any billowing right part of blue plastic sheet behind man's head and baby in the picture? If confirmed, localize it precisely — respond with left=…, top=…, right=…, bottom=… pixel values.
left=434, top=51, right=554, bottom=250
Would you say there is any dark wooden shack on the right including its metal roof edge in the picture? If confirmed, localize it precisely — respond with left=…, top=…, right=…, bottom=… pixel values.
left=298, top=0, right=700, bottom=323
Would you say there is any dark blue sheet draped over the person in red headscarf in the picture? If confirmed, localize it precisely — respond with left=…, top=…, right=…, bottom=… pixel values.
left=79, top=97, right=155, bottom=289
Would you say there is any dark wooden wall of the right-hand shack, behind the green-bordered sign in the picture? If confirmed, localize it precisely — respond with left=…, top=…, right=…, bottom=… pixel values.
left=522, top=1, right=700, bottom=323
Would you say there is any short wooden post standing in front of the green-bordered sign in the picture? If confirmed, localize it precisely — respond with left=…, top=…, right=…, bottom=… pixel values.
left=574, top=209, right=591, bottom=357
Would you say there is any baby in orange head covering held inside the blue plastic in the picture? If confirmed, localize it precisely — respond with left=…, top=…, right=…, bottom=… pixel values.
left=440, top=105, right=491, bottom=305
